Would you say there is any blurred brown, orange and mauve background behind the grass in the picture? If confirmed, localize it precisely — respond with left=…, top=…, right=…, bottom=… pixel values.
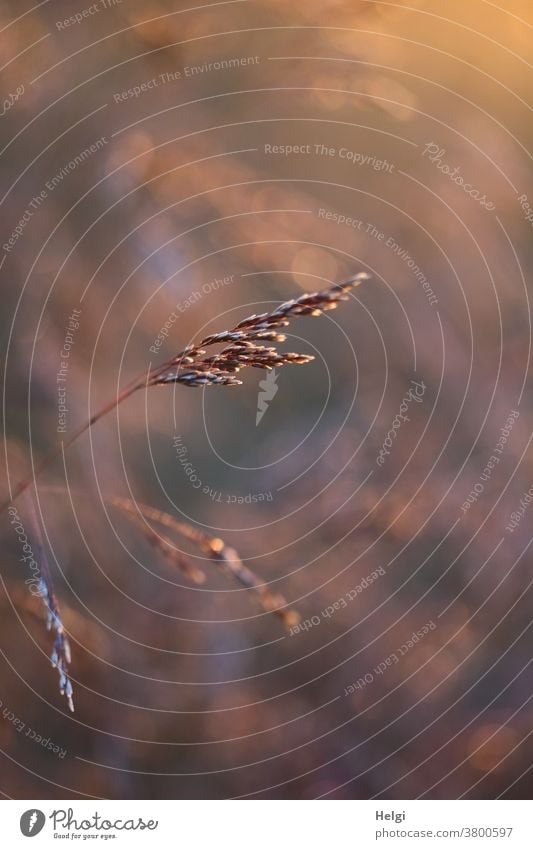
left=0, top=0, right=533, bottom=798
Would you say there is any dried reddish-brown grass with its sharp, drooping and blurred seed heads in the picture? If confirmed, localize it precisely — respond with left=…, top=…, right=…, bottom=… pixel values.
left=0, top=273, right=368, bottom=711
